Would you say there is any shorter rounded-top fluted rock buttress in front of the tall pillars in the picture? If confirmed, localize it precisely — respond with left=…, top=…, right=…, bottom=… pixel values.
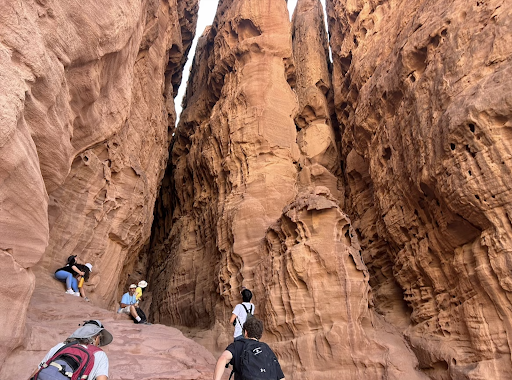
left=254, top=187, right=427, bottom=379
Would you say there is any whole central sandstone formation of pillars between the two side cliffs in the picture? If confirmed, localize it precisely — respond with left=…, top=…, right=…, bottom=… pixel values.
left=149, top=0, right=424, bottom=379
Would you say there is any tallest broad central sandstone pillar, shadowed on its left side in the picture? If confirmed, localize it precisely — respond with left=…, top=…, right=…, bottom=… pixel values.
left=150, top=0, right=300, bottom=327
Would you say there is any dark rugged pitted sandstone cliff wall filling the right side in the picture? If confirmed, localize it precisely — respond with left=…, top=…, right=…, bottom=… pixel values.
left=327, top=0, right=512, bottom=379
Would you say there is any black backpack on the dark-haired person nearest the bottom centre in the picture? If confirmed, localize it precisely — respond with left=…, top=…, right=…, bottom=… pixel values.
left=229, top=339, right=277, bottom=380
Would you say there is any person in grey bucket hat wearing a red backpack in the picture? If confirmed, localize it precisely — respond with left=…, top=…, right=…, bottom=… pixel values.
left=30, top=320, right=113, bottom=380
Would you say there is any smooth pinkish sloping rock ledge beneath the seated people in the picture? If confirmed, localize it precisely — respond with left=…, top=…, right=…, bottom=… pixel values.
left=0, top=285, right=215, bottom=380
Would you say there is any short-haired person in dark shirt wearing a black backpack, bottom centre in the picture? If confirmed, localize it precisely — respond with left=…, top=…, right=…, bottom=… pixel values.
left=213, top=317, right=284, bottom=380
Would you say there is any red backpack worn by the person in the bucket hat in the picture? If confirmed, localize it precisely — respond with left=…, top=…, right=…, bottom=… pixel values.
left=31, top=342, right=102, bottom=380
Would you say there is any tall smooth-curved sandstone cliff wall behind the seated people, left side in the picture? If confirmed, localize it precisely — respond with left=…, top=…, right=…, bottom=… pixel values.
left=0, top=0, right=198, bottom=366
